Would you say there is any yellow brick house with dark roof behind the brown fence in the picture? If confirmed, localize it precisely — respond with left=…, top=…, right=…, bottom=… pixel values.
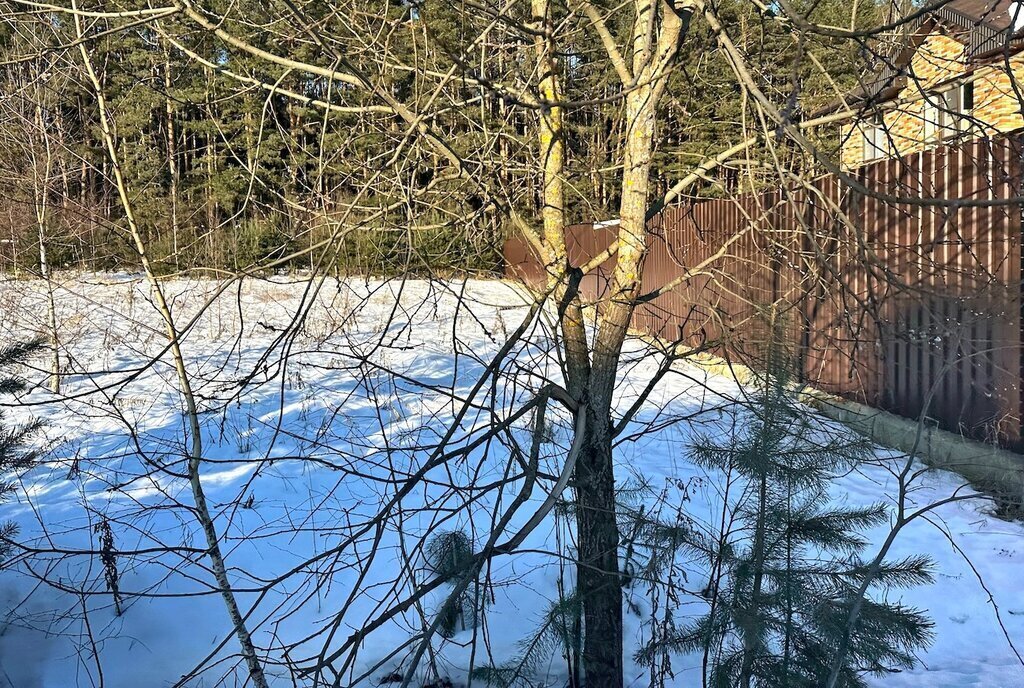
left=828, top=0, right=1024, bottom=169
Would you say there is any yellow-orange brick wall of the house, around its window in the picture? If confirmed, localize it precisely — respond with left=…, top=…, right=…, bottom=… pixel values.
left=840, top=32, right=1024, bottom=168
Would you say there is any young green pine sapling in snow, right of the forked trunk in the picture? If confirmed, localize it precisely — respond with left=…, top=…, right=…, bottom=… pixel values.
left=637, top=328, right=932, bottom=688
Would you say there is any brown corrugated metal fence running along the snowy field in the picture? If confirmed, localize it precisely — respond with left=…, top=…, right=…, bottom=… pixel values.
left=505, top=135, right=1024, bottom=450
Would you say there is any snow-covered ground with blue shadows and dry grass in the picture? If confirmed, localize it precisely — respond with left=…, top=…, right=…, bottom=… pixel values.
left=0, top=275, right=1024, bottom=688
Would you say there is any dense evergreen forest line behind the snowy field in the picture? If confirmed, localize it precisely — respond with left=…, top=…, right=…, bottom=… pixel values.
left=0, top=0, right=882, bottom=276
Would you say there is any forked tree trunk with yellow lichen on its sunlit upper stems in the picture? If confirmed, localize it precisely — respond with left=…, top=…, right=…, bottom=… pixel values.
left=534, top=0, right=689, bottom=688
